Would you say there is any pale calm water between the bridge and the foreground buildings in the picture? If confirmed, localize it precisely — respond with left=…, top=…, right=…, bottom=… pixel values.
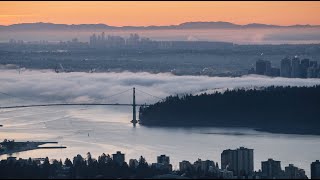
left=0, top=106, right=320, bottom=176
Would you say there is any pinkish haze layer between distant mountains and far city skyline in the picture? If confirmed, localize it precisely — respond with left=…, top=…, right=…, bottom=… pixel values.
left=0, top=28, right=320, bottom=44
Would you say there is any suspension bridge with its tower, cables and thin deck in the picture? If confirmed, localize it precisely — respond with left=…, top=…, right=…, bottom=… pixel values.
left=0, top=87, right=162, bottom=126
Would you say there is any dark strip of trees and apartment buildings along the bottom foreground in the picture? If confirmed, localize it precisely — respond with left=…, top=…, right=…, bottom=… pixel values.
left=0, top=146, right=320, bottom=179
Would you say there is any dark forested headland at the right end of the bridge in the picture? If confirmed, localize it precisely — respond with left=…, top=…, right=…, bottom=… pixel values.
left=139, top=86, right=320, bottom=135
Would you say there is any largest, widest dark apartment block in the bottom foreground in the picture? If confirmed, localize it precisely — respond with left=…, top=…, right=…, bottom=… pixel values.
left=221, top=147, right=253, bottom=176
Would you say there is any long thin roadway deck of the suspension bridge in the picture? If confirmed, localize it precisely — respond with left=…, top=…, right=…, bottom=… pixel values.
left=0, top=103, right=148, bottom=109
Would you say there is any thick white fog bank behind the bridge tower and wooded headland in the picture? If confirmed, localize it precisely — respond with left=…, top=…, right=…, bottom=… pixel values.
left=0, top=69, right=320, bottom=106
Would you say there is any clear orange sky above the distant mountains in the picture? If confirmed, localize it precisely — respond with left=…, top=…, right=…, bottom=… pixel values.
left=0, top=1, right=320, bottom=26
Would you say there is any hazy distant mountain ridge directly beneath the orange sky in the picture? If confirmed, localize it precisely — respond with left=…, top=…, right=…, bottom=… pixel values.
left=0, top=21, right=320, bottom=31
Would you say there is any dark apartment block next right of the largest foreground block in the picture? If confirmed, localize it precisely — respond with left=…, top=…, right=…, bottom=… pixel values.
left=261, top=159, right=282, bottom=179
